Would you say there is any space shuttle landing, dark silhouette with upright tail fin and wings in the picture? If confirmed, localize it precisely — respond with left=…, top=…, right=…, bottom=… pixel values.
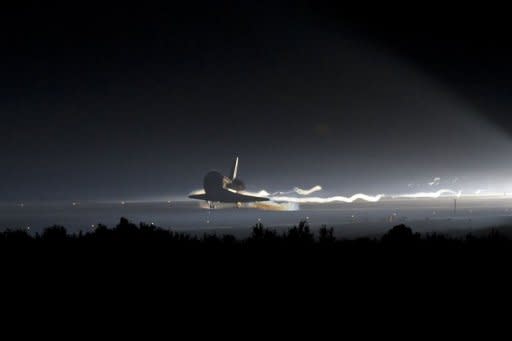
left=188, top=156, right=270, bottom=208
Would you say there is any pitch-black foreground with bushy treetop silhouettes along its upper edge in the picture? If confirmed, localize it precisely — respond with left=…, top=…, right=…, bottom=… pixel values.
left=0, top=219, right=512, bottom=325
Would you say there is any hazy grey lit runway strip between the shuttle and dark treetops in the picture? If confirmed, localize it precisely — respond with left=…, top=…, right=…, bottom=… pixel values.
left=0, top=197, right=512, bottom=237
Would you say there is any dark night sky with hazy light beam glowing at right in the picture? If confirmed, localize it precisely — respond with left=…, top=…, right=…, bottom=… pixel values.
left=0, top=1, right=512, bottom=201
